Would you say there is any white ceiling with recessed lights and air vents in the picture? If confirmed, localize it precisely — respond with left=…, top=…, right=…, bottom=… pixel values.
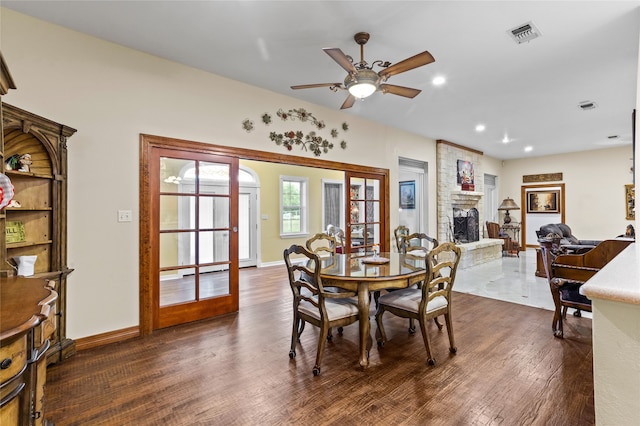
left=1, top=0, right=640, bottom=159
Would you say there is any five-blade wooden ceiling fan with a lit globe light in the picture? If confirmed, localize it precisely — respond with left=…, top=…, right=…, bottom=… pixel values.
left=291, top=32, right=435, bottom=109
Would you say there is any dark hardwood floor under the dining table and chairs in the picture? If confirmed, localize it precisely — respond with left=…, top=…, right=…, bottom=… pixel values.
left=46, top=266, right=595, bottom=426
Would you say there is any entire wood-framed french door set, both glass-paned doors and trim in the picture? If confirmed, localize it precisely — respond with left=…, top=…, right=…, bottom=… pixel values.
left=139, top=134, right=389, bottom=336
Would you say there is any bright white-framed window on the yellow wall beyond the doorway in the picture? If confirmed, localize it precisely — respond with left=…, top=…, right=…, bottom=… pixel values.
left=280, top=176, right=309, bottom=236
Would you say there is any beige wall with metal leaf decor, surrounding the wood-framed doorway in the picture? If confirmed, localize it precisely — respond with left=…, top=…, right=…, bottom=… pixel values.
left=0, top=8, right=436, bottom=338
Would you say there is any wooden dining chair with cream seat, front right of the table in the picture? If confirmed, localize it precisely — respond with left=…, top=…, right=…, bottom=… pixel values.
left=376, top=242, right=460, bottom=365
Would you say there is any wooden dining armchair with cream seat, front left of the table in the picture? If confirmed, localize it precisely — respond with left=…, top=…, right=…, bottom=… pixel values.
left=284, top=244, right=358, bottom=376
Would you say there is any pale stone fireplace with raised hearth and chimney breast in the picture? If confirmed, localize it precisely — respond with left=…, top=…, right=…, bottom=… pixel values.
left=436, top=140, right=502, bottom=268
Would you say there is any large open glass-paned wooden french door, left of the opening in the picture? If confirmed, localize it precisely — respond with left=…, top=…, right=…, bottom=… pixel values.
left=149, top=148, right=238, bottom=329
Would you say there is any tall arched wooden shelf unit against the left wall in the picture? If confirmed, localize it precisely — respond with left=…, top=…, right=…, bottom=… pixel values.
left=0, top=103, right=76, bottom=364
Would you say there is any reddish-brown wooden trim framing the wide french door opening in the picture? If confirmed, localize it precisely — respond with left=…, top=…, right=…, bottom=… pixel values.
left=139, top=134, right=390, bottom=336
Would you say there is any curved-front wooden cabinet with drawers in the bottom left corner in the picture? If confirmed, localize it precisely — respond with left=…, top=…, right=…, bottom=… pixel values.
left=0, top=277, right=58, bottom=426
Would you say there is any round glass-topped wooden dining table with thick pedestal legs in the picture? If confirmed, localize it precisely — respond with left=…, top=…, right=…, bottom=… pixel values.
left=320, top=252, right=425, bottom=368
